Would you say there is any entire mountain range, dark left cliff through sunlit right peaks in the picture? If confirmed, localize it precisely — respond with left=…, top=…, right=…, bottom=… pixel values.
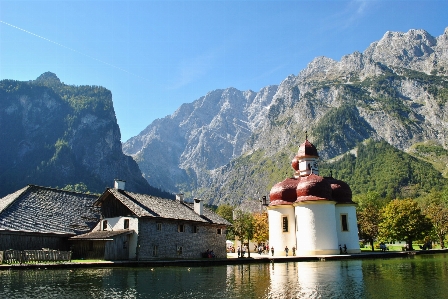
left=0, top=28, right=448, bottom=205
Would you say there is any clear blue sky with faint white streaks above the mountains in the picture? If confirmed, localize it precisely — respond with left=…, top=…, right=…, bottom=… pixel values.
left=0, top=0, right=448, bottom=141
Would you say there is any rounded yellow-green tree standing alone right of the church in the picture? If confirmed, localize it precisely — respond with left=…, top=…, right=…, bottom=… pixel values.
left=379, top=199, right=432, bottom=250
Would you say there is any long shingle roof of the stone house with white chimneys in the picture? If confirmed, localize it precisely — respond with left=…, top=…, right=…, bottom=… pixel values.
left=96, top=188, right=230, bottom=225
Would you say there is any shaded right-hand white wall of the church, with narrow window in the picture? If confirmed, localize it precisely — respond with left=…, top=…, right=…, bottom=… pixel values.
left=335, top=204, right=361, bottom=253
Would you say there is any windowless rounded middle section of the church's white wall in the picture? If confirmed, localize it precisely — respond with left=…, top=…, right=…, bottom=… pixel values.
left=295, top=201, right=339, bottom=255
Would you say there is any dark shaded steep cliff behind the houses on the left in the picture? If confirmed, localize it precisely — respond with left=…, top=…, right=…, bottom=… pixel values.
left=0, top=73, right=151, bottom=197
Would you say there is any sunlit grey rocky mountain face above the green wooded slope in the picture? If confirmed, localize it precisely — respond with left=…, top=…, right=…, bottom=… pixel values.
left=123, top=28, right=448, bottom=203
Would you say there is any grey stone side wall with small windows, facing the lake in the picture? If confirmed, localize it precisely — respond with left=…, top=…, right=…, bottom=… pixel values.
left=137, top=219, right=227, bottom=260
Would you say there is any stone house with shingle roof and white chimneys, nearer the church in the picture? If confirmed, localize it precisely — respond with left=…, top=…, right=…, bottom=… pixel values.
left=71, top=181, right=230, bottom=260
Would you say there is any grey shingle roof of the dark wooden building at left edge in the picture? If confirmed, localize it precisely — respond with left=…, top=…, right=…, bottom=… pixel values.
left=0, top=185, right=99, bottom=234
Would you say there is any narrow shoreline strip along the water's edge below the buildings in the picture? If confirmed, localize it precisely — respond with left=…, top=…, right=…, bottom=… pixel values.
left=0, top=249, right=448, bottom=271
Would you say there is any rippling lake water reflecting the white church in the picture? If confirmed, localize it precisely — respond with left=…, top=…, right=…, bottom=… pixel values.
left=0, top=254, right=448, bottom=299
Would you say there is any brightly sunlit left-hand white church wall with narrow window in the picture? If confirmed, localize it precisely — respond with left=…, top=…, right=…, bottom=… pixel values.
left=268, top=205, right=296, bottom=256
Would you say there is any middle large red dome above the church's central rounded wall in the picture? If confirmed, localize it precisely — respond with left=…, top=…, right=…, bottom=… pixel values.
left=296, top=174, right=332, bottom=201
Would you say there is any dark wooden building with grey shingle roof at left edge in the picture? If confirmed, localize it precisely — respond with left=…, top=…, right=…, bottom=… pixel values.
left=0, top=185, right=99, bottom=251
